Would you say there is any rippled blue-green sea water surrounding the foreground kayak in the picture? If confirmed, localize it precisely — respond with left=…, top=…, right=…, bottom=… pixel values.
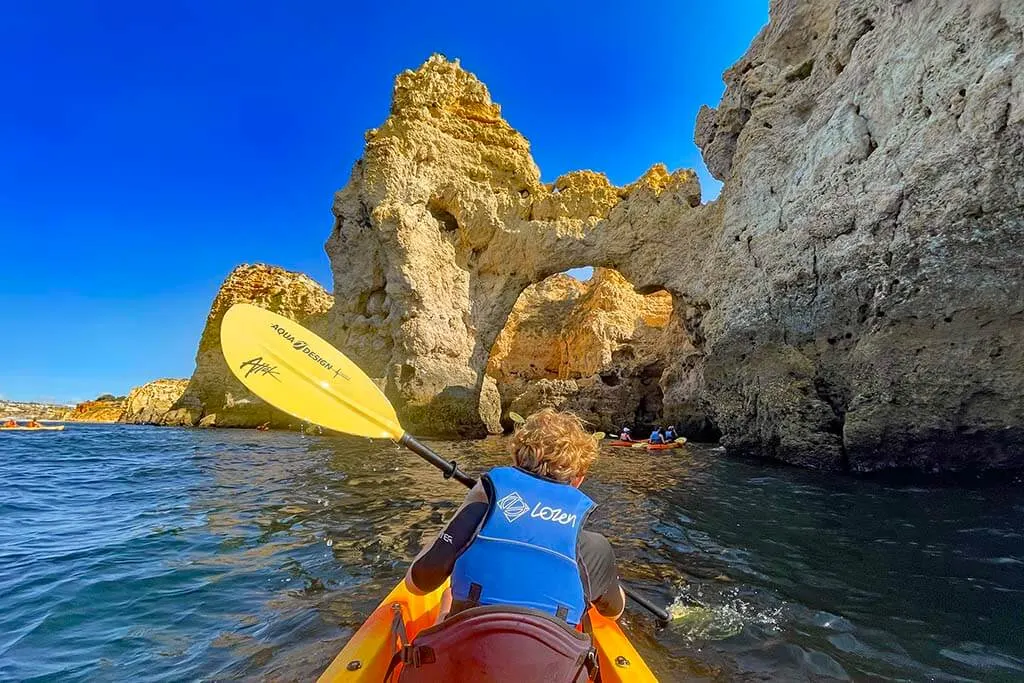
left=0, top=425, right=1024, bottom=681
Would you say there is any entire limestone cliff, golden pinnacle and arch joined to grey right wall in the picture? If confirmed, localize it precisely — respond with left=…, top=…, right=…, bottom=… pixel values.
left=325, top=0, right=1024, bottom=470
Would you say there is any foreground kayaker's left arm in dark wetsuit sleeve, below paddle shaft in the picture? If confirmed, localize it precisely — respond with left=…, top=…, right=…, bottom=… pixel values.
left=406, top=482, right=487, bottom=595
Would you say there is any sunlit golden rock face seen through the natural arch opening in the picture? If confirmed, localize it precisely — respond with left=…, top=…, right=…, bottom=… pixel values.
left=487, top=268, right=676, bottom=431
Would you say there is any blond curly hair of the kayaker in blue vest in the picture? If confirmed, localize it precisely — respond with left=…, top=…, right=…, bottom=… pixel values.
left=510, top=408, right=598, bottom=483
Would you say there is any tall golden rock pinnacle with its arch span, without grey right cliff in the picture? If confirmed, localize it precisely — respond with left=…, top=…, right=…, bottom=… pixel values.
left=326, top=56, right=714, bottom=435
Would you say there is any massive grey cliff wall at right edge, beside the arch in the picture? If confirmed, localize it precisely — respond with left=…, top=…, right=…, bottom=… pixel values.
left=696, top=0, right=1024, bottom=470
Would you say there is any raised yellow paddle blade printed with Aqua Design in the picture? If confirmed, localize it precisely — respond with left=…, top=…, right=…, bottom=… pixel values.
left=220, top=303, right=404, bottom=440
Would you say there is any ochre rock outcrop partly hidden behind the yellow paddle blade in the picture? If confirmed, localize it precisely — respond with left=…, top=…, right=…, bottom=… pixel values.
left=161, top=264, right=333, bottom=427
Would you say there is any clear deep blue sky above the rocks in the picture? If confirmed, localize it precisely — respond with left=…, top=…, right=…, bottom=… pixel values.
left=0, top=0, right=768, bottom=401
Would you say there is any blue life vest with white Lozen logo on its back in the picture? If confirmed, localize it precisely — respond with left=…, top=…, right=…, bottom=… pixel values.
left=452, top=467, right=594, bottom=626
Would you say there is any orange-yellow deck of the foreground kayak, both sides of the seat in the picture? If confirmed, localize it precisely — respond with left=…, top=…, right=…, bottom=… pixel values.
left=317, top=582, right=657, bottom=683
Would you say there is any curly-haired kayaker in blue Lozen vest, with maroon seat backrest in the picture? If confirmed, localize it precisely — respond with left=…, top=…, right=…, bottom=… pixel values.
left=396, top=409, right=626, bottom=681
